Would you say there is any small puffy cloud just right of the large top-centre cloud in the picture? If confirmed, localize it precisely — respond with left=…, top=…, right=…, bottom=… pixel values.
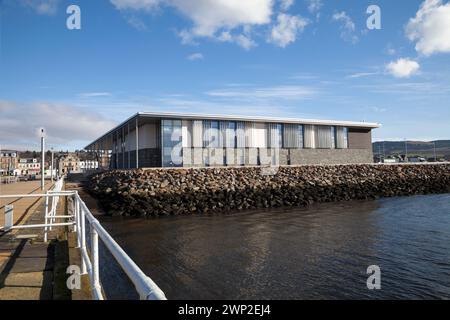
left=269, top=13, right=308, bottom=48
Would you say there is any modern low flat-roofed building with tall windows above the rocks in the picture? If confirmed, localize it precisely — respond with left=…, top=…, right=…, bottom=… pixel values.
left=85, top=112, right=380, bottom=169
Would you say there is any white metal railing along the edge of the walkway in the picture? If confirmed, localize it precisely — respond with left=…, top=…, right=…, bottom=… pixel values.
left=0, top=179, right=166, bottom=300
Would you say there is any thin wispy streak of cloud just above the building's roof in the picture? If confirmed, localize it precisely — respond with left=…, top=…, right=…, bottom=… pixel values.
left=207, top=86, right=317, bottom=100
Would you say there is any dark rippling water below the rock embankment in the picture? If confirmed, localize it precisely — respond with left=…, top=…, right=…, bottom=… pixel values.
left=97, top=194, right=450, bottom=299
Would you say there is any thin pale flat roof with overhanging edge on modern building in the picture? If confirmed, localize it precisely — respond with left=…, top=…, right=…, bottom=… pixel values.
left=85, top=112, right=381, bottom=149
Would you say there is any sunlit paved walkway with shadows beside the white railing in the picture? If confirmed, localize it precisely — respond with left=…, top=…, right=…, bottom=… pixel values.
left=0, top=181, right=70, bottom=300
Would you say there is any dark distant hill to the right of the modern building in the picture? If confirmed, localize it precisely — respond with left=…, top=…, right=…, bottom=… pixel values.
left=372, top=140, right=450, bottom=160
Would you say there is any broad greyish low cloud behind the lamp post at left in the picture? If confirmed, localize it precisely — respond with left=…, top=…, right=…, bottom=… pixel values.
left=0, top=101, right=114, bottom=147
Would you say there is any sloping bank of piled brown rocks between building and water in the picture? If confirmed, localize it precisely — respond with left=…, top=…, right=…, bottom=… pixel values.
left=86, top=163, right=450, bottom=216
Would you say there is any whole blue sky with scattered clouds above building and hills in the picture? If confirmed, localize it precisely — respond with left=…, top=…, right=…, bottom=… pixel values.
left=0, top=0, right=450, bottom=149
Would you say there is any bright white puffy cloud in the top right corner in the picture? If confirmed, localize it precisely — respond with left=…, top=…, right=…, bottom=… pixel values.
left=406, top=0, right=450, bottom=56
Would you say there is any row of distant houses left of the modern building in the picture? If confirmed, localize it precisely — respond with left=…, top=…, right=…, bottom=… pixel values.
left=0, top=150, right=98, bottom=177
